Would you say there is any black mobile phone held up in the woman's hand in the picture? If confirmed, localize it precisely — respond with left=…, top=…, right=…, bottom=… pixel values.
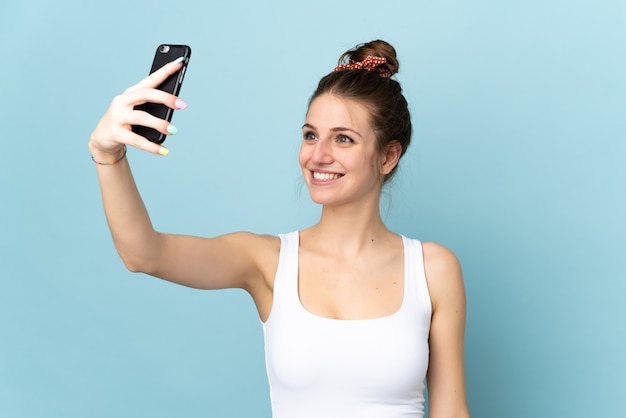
left=133, top=44, right=191, bottom=144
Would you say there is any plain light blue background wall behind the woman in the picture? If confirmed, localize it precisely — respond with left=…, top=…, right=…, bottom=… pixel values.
left=0, top=0, right=626, bottom=418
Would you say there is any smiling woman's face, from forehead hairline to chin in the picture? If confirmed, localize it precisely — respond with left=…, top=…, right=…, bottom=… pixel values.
left=299, top=94, right=386, bottom=205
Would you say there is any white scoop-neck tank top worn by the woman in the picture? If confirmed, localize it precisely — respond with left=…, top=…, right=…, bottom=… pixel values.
left=263, top=231, right=432, bottom=418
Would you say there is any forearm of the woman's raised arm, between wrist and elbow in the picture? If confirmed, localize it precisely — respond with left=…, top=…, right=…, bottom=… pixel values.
left=92, top=149, right=159, bottom=271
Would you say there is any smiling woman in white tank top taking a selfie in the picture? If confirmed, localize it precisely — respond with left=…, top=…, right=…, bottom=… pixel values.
left=89, top=41, right=469, bottom=418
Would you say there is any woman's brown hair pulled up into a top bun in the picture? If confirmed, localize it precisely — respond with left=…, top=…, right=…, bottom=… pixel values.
left=309, top=40, right=413, bottom=182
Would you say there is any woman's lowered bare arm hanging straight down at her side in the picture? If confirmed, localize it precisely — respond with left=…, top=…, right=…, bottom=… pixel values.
left=423, top=243, right=470, bottom=418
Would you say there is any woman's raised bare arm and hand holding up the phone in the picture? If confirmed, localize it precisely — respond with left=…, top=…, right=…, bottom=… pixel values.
left=89, top=59, right=280, bottom=299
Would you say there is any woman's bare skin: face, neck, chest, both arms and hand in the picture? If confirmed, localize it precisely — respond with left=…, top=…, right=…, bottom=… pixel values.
left=89, top=60, right=469, bottom=418
